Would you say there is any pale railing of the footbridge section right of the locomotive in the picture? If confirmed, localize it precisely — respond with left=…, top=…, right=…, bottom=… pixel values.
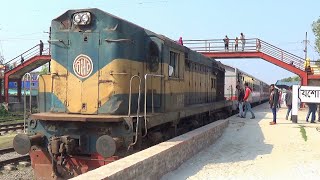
left=183, top=38, right=304, bottom=70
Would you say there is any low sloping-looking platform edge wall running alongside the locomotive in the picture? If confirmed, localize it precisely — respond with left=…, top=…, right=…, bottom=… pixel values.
left=73, top=119, right=229, bottom=180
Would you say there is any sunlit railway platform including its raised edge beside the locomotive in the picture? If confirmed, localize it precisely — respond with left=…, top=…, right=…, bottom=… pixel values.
left=74, top=103, right=320, bottom=180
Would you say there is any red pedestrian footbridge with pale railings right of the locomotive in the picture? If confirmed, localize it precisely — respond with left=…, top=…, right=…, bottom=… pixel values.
left=183, top=38, right=320, bottom=85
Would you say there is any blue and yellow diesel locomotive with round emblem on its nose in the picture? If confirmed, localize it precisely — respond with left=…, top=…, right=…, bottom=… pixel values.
left=13, top=8, right=268, bottom=179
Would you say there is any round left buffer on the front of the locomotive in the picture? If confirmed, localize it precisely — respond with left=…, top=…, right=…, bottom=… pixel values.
left=13, top=134, right=43, bottom=155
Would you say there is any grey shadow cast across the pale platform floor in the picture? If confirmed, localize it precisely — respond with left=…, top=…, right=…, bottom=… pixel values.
left=162, top=103, right=273, bottom=180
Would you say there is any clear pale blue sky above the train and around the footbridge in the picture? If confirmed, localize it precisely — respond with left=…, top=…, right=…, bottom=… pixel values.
left=0, top=0, right=320, bottom=84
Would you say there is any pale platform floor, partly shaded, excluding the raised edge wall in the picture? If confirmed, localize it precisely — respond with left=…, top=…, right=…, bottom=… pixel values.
left=162, top=103, right=320, bottom=180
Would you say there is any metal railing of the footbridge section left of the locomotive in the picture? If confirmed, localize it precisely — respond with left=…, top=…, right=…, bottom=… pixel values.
left=3, top=44, right=50, bottom=72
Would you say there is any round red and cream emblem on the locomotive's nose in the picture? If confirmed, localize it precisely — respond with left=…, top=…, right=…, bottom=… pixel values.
left=73, top=54, right=93, bottom=78
